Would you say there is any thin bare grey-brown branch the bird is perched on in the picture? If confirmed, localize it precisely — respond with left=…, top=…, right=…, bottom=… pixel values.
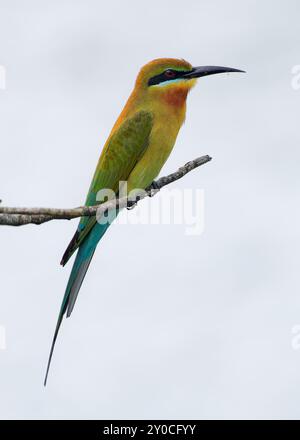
left=0, top=156, right=211, bottom=226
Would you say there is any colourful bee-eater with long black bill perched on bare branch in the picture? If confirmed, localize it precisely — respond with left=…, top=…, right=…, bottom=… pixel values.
left=44, top=58, right=244, bottom=386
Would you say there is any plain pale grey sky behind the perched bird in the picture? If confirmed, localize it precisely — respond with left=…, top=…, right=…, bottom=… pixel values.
left=0, top=0, right=300, bottom=419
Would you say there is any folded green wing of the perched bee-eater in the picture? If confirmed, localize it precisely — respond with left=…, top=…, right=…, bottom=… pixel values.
left=61, top=111, right=153, bottom=266
